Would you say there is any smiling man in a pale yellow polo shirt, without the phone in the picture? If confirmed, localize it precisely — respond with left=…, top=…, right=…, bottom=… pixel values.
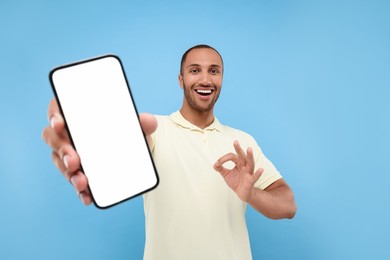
left=43, top=45, right=296, bottom=260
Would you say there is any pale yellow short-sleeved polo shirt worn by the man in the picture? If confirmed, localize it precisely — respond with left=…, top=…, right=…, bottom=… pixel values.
left=144, top=112, right=281, bottom=260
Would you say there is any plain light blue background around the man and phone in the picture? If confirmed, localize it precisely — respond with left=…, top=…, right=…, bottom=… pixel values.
left=0, top=0, right=390, bottom=260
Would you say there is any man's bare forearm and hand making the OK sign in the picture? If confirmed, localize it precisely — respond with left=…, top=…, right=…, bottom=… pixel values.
left=214, top=141, right=296, bottom=219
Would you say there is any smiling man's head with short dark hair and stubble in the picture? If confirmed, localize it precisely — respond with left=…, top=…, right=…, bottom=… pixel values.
left=179, top=48, right=223, bottom=112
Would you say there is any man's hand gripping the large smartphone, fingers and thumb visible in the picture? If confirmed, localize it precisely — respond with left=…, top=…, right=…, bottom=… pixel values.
left=42, top=98, right=157, bottom=205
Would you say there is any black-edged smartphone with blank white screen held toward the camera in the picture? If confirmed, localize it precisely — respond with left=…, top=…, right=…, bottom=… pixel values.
left=49, top=55, right=159, bottom=209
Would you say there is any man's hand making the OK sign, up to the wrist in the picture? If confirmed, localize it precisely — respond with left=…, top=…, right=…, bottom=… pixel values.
left=214, top=141, right=264, bottom=202
